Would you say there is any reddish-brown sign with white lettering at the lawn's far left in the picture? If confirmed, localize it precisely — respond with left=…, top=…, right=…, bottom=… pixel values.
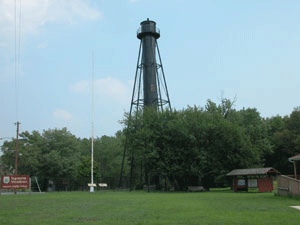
left=1, top=175, right=30, bottom=189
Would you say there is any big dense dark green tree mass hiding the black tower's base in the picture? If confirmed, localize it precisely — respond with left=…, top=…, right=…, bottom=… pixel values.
left=125, top=101, right=262, bottom=190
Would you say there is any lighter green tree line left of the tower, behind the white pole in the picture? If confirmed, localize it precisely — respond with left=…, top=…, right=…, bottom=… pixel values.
left=0, top=128, right=124, bottom=190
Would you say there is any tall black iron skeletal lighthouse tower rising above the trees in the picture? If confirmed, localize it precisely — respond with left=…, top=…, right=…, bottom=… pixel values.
left=119, top=18, right=172, bottom=189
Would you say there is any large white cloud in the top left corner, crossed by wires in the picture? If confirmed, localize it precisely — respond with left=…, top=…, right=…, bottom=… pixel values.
left=0, top=0, right=101, bottom=34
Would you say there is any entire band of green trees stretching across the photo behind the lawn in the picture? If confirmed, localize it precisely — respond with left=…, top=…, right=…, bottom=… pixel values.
left=0, top=99, right=300, bottom=190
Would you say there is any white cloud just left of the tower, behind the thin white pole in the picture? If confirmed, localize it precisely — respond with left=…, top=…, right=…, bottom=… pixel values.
left=71, top=77, right=131, bottom=104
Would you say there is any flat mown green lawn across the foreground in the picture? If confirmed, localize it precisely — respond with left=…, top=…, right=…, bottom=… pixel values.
left=0, top=191, right=300, bottom=225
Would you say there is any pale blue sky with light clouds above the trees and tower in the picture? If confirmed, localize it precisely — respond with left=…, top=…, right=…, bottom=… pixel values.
left=0, top=0, right=300, bottom=145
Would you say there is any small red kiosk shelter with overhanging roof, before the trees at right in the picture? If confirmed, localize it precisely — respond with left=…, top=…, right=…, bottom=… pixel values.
left=227, top=167, right=280, bottom=192
